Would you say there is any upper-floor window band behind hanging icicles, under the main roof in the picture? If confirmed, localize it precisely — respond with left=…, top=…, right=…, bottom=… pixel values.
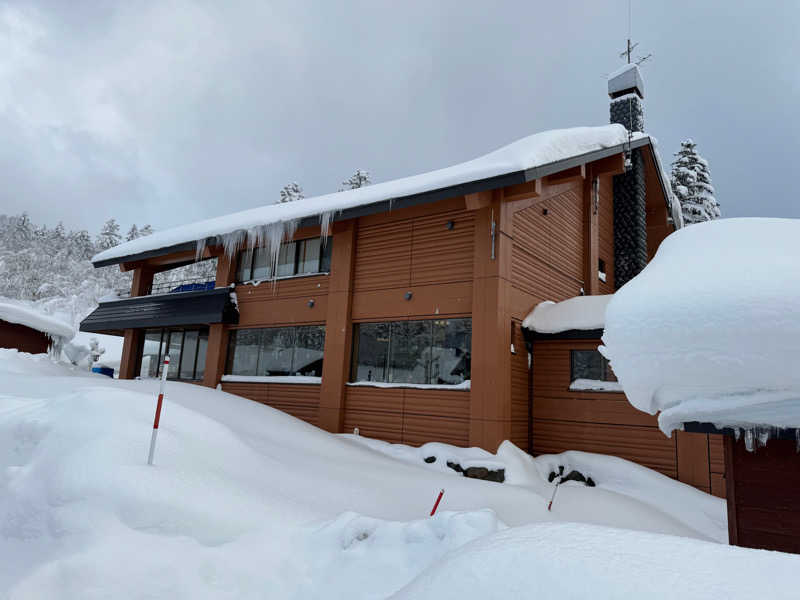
left=236, top=238, right=333, bottom=282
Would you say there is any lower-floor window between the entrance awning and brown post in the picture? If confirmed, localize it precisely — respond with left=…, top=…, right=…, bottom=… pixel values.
left=225, top=325, right=325, bottom=377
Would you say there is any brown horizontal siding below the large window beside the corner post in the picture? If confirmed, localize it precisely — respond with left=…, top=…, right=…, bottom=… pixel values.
left=344, top=386, right=469, bottom=446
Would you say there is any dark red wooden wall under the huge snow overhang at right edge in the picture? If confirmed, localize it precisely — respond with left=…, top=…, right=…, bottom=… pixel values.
left=728, top=436, right=800, bottom=553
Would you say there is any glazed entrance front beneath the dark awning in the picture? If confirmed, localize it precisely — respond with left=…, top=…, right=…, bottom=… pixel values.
left=139, top=329, right=208, bottom=380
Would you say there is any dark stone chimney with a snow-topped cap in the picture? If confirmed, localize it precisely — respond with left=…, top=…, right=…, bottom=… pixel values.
left=608, top=64, right=647, bottom=289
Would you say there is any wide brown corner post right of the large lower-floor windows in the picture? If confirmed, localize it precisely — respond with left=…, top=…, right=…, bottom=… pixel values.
left=469, top=190, right=511, bottom=452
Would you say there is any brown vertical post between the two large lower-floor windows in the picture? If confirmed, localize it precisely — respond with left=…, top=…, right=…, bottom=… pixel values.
left=318, top=220, right=357, bottom=433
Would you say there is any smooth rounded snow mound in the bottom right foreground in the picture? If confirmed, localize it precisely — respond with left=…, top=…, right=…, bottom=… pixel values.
left=393, top=523, right=800, bottom=600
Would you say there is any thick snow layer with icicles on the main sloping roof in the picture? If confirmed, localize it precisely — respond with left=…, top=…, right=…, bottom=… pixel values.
left=92, top=124, right=669, bottom=263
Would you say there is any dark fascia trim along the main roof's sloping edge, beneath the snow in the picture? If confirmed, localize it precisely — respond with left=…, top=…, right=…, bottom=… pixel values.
left=93, top=136, right=664, bottom=268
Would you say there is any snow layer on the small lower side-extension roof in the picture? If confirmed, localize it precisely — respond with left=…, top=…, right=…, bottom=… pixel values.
left=522, top=294, right=612, bottom=333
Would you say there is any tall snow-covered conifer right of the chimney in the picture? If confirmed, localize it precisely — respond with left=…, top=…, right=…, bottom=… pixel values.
left=670, top=139, right=721, bottom=225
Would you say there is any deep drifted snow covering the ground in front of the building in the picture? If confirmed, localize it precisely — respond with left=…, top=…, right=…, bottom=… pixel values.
left=0, top=350, right=800, bottom=599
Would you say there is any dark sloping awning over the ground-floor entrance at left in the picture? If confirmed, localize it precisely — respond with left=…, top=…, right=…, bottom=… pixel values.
left=80, top=288, right=239, bottom=334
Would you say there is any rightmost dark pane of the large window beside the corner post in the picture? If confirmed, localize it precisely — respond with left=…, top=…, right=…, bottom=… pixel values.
left=429, top=319, right=472, bottom=384
